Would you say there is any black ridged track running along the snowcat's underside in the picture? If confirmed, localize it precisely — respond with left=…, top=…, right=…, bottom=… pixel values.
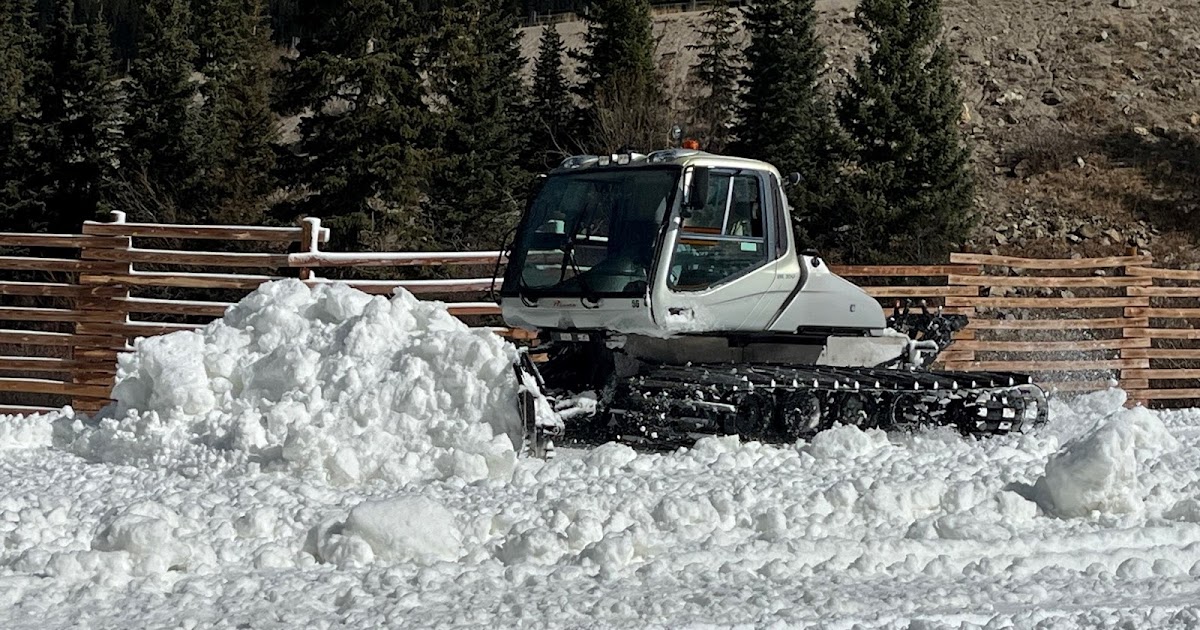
left=565, top=364, right=1048, bottom=449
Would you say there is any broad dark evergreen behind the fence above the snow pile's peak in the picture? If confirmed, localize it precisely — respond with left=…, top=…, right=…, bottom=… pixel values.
left=275, top=0, right=428, bottom=248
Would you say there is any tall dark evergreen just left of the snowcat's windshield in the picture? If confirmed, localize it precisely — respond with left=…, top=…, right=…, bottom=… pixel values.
left=428, top=0, right=528, bottom=250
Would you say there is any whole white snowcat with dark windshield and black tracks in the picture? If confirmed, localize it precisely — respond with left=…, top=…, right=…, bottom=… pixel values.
left=500, top=149, right=1045, bottom=454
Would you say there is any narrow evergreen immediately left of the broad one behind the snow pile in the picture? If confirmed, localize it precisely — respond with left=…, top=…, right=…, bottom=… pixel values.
left=196, top=0, right=278, bottom=223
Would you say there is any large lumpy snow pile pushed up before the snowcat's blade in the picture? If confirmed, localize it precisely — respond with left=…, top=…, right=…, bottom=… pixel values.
left=60, top=280, right=521, bottom=485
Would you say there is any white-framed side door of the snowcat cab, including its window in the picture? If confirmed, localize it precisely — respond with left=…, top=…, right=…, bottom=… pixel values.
left=654, top=169, right=791, bottom=332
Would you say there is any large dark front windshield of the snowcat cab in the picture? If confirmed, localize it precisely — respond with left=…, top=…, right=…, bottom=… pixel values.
left=506, top=167, right=679, bottom=296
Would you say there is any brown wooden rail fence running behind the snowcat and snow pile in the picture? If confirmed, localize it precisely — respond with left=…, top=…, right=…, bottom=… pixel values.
left=0, top=214, right=1200, bottom=413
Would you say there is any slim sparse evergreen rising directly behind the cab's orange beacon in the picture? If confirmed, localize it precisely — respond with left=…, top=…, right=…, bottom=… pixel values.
left=688, top=0, right=742, bottom=152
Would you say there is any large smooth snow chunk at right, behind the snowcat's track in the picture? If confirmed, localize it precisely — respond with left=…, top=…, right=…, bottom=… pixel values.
left=1036, top=407, right=1177, bottom=517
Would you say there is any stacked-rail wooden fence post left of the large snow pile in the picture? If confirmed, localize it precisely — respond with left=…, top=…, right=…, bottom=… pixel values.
left=71, top=211, right=133, bottom=414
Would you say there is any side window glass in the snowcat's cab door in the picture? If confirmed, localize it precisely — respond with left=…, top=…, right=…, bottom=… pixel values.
left=670, top=172, right=768, bottom=290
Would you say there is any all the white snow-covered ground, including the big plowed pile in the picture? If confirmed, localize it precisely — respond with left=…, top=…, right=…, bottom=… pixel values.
left=0, top=281, right=1200, bottom=630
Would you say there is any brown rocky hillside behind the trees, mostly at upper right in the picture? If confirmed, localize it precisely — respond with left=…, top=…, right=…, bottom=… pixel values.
left=524, top=0, right=1200, bottom=266
